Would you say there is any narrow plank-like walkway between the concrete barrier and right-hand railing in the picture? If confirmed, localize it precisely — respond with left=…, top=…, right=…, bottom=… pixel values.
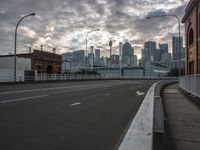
left=162, top=84, right=200, bottom=150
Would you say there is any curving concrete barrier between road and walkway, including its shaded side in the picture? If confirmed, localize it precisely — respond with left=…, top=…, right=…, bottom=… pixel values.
left=118, top=80, right=176, bottom=150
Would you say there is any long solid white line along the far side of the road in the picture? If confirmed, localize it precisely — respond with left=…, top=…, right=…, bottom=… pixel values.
left=0, top=83, right=110, bottom=95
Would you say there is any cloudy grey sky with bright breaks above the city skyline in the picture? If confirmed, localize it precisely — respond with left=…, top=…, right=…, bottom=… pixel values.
left=0, top=0, right=189, bottom=57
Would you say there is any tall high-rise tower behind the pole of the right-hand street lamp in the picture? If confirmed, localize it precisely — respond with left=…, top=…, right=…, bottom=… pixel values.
left=172, top=36, right=183, bottom=60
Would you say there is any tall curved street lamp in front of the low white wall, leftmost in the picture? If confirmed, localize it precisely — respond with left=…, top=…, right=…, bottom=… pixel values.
left=14, top=13, right=35, bottom=82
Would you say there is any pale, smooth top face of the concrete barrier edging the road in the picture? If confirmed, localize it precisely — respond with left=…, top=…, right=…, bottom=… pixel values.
left=118, top=83, right=157, bottom=150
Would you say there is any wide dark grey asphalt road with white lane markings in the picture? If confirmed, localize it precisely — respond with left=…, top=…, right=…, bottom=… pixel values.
left=0, top=81, right=153, bottom=150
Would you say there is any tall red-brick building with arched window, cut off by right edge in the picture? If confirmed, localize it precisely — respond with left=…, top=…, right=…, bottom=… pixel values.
left=182, top=0, right=200, bottom=75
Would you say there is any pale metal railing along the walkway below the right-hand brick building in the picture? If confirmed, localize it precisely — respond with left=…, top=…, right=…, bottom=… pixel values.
left=179, top=75, right=200, bottom=97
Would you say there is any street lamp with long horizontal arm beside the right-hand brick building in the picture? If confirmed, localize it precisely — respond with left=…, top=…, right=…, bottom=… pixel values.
left=146, top=14, right=181, bottom=76
